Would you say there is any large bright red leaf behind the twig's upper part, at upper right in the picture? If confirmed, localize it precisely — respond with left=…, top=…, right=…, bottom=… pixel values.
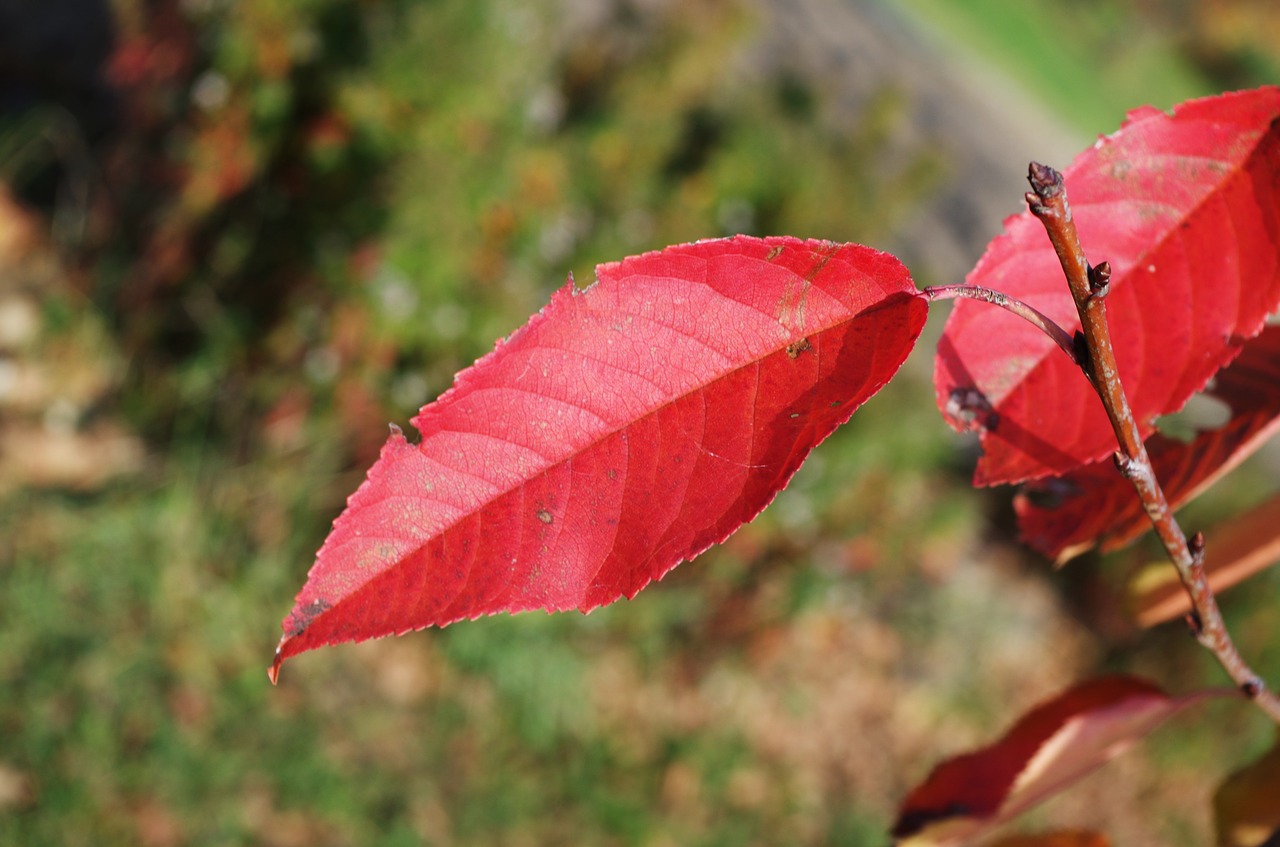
left=934, top=87, right=1280, bottom=485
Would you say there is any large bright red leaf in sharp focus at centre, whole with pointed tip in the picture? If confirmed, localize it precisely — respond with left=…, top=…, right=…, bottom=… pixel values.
left=273, top=237, right=927, bottom=678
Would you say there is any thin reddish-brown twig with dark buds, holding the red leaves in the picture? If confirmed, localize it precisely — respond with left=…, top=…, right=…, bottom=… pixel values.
left=1027, top=162, right=1280, bottom=723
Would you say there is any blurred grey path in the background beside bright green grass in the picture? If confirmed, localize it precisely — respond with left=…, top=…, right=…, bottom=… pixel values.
left=754, top=0, right=1091, bottom=284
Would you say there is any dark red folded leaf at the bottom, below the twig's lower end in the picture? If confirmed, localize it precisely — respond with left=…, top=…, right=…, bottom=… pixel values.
left=892, top=676, right=1239, bottom=846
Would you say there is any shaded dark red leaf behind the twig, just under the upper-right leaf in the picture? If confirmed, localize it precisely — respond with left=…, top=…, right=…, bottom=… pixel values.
left=1014, top=326, right=1280, bottom=562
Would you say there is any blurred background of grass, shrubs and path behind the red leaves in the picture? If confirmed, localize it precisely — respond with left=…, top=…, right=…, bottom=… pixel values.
left=0, top=0, right=1280, bottom=847
